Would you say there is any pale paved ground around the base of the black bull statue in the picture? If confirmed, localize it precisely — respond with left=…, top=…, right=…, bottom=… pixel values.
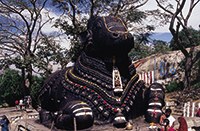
left=0, top=107, right=200, bottom=131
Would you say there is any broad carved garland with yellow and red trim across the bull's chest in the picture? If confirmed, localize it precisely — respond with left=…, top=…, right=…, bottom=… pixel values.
left=62, top=54, right=143, bottom=118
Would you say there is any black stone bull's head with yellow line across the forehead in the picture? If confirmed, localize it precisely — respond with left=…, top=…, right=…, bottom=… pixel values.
left=80, top=16, right=134, bottom=57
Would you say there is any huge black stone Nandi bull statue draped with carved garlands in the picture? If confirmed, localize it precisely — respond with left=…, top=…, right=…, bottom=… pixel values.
left=39, top=16, right=165, bottom=129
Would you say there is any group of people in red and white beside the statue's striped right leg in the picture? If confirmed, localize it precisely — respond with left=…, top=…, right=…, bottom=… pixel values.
left=159, top=108, right=188, bottom=131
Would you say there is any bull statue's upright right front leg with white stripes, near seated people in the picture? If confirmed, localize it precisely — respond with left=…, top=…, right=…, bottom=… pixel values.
left=145, top=83, right=165, bottom=123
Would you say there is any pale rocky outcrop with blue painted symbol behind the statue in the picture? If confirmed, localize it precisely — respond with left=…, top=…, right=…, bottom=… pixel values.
left=133, top=46, right=200, bottom=85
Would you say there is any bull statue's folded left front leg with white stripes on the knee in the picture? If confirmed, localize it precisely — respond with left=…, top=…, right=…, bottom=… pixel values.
left=55, top=101, right=94, bottom=130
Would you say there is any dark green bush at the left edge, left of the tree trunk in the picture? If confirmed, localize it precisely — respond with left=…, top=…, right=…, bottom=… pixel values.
left=0, top=69, right=23, bottom=106
